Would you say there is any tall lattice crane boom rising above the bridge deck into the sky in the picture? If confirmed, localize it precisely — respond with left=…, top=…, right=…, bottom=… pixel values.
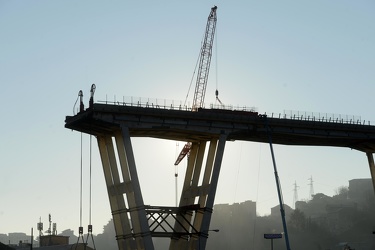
left=192, top=6, right=217, bottom=111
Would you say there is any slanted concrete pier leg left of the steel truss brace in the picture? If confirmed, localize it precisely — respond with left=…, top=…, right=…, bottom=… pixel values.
left=97, top=126, right=154, bottom=250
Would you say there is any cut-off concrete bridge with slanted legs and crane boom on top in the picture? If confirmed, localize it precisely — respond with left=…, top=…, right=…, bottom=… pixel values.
left=65, top=6, right=375, bottom=250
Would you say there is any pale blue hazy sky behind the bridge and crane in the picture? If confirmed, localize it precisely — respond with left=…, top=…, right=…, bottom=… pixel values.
left=0, top=0, right=375, bottom=234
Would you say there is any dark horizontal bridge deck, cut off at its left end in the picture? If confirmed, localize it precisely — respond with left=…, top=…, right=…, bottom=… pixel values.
left=65, top=103, right=375, bottom=153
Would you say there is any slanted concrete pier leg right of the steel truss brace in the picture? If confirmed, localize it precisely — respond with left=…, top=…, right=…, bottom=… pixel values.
left=169, top=134, right=227, bottom=250
